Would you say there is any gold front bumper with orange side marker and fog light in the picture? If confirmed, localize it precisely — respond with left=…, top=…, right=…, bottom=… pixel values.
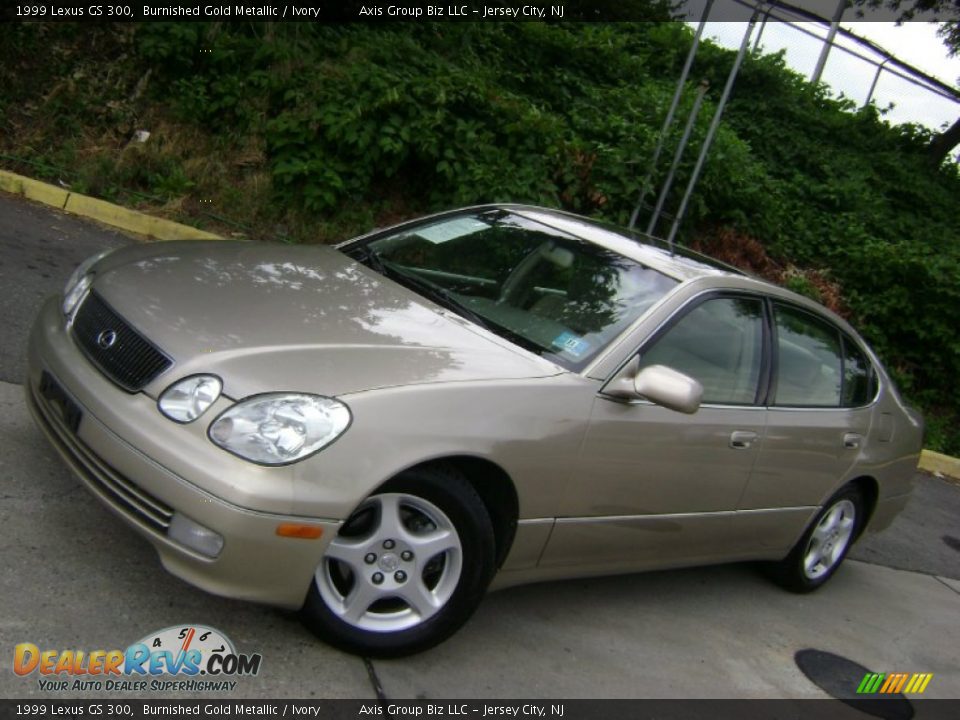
left=26, top=299, right=339, bottom=608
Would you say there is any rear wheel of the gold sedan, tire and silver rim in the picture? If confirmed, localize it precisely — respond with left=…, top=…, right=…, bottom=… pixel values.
left=769, top=485, right=865, bottom=593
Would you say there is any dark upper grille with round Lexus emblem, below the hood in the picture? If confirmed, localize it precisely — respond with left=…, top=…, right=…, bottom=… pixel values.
left=73, top=291, right=173, bottom=392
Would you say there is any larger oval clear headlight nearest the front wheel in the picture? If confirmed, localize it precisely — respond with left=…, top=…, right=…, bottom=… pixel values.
left=210, top=393, right=350, bottom=465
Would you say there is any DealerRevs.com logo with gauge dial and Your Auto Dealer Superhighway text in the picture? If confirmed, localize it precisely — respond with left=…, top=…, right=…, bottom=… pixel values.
left=13, top=625, right=263, bottom=692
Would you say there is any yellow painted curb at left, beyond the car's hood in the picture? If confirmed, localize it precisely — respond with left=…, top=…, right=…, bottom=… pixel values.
left=0, top=170, right=223, bottom=240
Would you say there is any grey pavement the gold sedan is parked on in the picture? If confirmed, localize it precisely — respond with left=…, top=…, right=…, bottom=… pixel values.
left=0, top=190, right=960, bottom=699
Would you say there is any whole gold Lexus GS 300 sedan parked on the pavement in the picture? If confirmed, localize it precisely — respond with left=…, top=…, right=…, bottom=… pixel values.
left=28, top=205, right=923, bottom=655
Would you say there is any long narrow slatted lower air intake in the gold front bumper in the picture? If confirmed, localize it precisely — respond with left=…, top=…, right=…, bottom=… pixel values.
left=28, top=373, right=174, bottom=535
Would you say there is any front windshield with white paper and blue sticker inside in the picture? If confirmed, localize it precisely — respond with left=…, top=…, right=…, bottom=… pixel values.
left=348, top=210, right=677, bottom=370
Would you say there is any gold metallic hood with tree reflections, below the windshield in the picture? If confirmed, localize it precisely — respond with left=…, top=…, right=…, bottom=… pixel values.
left=94, top=242, right=563, bottom=398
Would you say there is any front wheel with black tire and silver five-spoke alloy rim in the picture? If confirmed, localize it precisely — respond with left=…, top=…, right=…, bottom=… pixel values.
left=301, top=467, right=495, bottom=657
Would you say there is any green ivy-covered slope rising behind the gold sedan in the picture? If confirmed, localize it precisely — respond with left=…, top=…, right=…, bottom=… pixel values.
left=0, top=22, right=960, bottom=454
